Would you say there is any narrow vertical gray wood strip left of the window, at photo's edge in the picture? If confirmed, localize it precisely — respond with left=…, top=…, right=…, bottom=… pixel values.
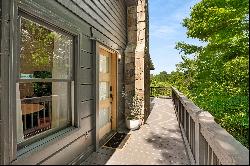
left=0, top=1, right=12, bottom=165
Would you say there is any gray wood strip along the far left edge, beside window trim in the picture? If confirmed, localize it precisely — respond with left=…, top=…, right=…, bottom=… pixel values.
left=0, top=0, right=11, bottom=165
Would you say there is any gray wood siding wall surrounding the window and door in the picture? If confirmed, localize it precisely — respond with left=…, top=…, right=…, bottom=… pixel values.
left=3, top=0, right=127, bottom=164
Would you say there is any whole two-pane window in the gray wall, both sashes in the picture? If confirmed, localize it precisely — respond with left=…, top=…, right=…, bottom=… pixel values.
left=16, top=17, right=73, bottom=145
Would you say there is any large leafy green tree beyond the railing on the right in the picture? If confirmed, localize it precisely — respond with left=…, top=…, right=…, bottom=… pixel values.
left=176, top=0, right=249, bottom=147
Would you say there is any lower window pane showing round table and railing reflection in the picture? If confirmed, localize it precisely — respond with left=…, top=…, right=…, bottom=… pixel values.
left=17, top=82, right=70, bottom=139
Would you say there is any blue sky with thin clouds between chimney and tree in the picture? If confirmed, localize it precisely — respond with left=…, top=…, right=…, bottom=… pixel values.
left=149, top=0, right=200, bottom=74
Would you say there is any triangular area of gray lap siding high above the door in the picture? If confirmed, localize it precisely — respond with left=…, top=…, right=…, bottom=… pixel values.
left=57, top=0, right=127, bottom=49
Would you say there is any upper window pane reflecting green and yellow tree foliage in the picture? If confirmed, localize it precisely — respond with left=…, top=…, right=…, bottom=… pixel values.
left=20, top=18, right=73, bottom=79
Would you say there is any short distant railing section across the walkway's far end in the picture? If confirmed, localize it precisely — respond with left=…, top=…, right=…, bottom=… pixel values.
left=150, top=87, right=171, bottom=97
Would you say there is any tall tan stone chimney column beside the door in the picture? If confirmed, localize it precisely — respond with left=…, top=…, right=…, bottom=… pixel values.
left=125, top=0, right=150, bottom=121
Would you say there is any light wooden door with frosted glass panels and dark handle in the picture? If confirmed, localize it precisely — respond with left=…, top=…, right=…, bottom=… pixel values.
left=99, top=49, right=116, bottom=140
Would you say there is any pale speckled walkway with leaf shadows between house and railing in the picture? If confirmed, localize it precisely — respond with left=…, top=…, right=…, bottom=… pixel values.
left=82, top=98, right=190, bottom=165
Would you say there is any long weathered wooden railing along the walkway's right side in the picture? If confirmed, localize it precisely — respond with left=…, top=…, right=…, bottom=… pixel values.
left=172, top=87, right=249, bottom=165
